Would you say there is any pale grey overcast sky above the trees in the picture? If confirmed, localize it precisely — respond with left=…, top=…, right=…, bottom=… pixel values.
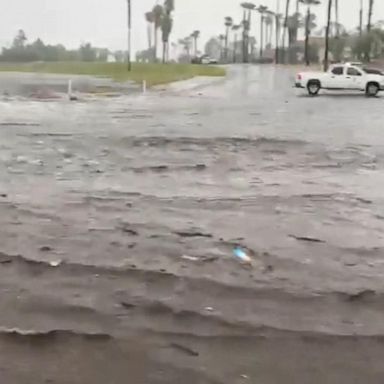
left=0, top=0, right=384, bottom=50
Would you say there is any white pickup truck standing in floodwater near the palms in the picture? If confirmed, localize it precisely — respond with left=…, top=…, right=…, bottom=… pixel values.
left=295, top=64, right=384, bottom=96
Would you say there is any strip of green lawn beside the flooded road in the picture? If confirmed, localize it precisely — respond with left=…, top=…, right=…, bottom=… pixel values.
left=0, top=62, right=225, bottom=86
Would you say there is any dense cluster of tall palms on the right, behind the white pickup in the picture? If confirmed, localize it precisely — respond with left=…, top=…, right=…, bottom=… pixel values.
left=207, top=0, right=378, bottom=65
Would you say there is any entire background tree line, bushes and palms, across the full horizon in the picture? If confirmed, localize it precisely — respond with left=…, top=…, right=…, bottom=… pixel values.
left=0, top=0, right=384, bottom=66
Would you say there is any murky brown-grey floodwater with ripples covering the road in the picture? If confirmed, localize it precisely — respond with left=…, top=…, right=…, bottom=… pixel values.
left=0, top=66, right=384, bottom=384
